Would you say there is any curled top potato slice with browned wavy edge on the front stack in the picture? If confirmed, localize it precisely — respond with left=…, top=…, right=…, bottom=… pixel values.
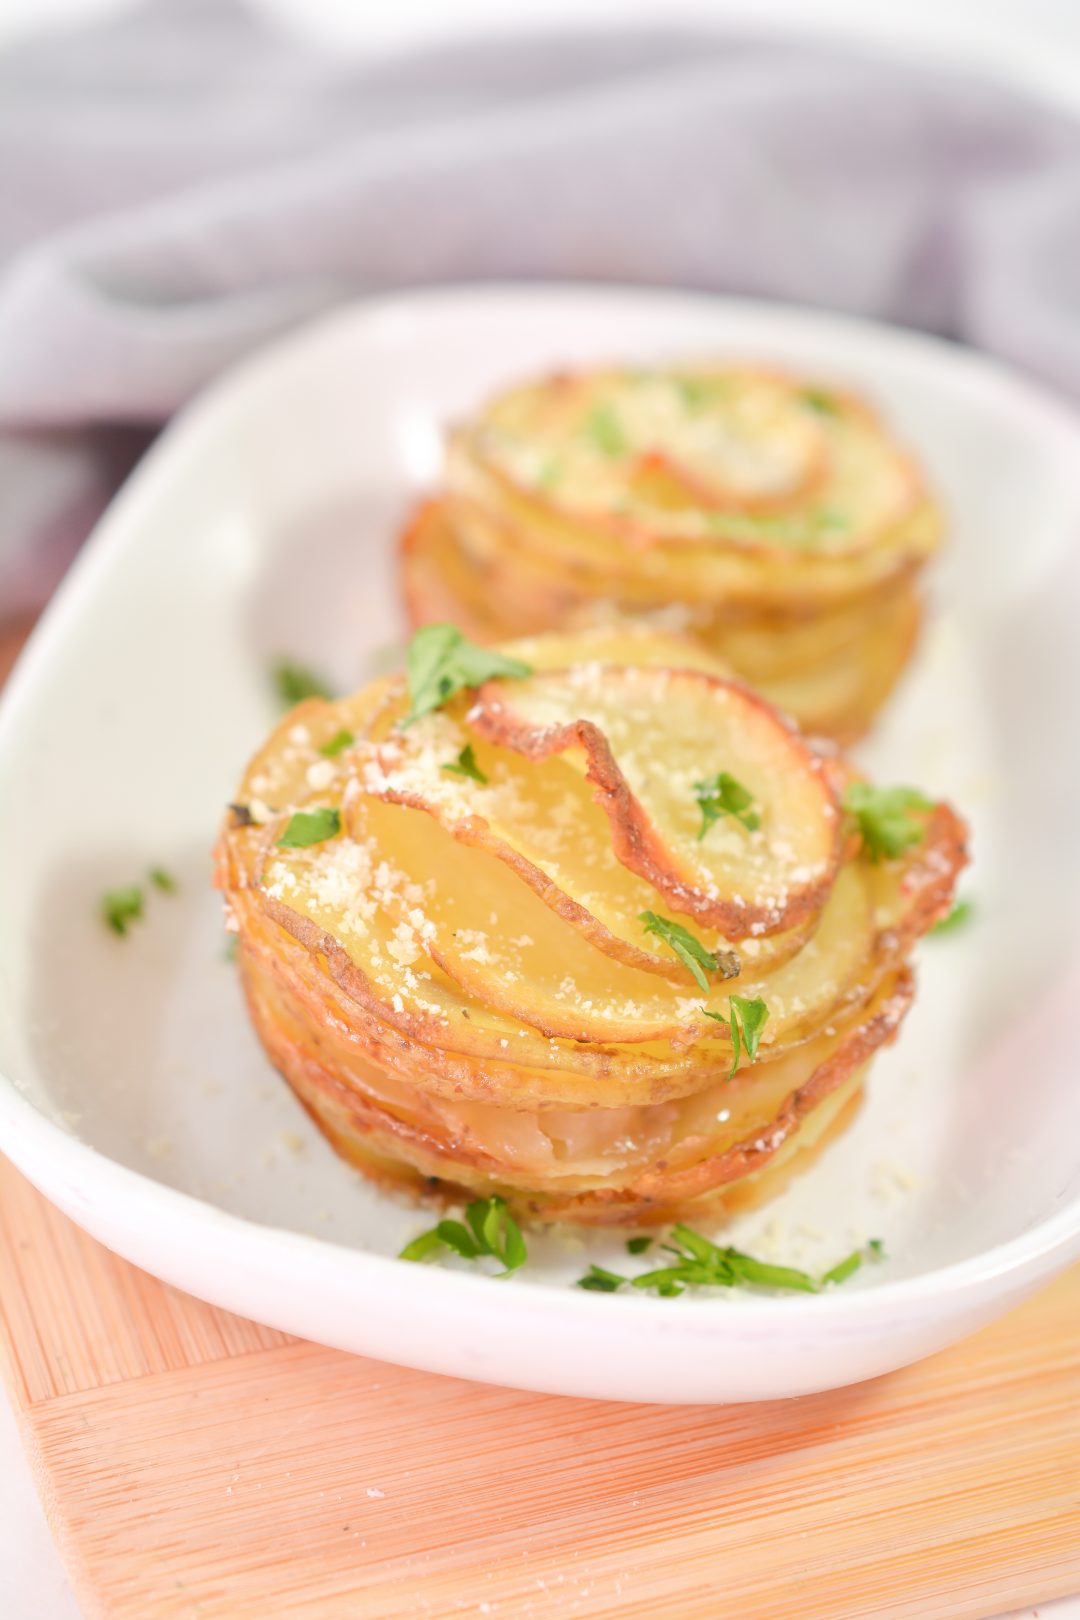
left=468, top=666, right=840, bottom=940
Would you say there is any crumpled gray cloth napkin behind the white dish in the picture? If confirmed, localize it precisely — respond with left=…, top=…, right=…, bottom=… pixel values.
left=0, top=0, right=1080, bottom=616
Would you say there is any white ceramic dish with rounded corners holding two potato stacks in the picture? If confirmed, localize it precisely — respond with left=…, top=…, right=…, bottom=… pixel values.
left=0, top=288, right=1080, bottom=1401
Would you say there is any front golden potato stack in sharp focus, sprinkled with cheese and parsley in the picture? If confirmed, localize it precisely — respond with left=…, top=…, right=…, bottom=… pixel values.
left=217, top=625, right=965, bottom=1223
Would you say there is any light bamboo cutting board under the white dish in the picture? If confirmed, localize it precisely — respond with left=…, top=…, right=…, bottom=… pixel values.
left=0, top=622, right=1080, bottom=1620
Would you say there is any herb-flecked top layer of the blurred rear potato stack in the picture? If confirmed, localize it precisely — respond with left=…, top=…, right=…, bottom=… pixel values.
left=449, top=368, right=920, bottom=556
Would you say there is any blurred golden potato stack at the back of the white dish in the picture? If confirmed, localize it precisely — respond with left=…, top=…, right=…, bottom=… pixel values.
left=402, top=366, right=941, bottom=742
